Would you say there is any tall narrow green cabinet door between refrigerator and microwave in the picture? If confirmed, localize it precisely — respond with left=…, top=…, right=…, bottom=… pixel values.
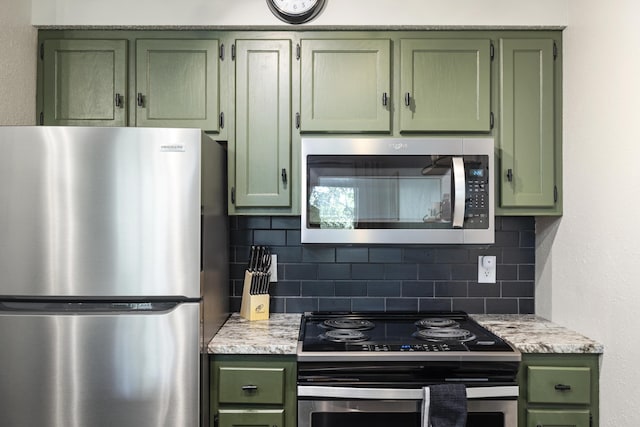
left=234, top=40, right=293, bottom=208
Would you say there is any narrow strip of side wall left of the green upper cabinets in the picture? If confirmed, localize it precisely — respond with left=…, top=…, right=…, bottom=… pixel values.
left=0, top=0, right=37, bottom=125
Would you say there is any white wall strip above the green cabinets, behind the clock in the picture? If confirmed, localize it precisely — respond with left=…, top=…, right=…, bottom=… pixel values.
left=32, top=0, right=567, bottom=27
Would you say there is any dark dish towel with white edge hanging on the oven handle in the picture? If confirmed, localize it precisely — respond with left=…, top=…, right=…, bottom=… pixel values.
left=421, top=384, right=467, bottom=427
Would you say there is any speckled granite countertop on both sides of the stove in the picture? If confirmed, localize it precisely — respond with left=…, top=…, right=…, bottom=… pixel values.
left=207, top=313, right=604, bottom=355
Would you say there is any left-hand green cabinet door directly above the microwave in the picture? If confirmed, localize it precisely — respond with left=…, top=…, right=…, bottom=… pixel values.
left=300, top=39, right=391, bottom=133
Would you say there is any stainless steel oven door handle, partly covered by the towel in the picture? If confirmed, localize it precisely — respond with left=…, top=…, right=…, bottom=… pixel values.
left=298, top=385, right=518, bottom=400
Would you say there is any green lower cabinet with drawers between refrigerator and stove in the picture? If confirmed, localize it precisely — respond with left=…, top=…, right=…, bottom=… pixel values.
left=209, top=355, right=297, bottom=427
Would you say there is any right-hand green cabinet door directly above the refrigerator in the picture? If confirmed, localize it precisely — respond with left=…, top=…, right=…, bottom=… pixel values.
left=135, top=39, right=219, bottom=132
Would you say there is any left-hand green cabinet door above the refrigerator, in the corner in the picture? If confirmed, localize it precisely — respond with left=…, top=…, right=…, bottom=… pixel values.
left=42, top=40, right=127, bottom=126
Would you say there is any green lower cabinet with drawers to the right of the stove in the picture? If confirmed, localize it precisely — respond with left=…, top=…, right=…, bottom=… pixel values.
left=518, top=354, right=599, bottom=427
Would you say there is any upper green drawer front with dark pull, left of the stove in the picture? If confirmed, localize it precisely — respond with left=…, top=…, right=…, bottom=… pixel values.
left=218, top=367, right=284, bottom=404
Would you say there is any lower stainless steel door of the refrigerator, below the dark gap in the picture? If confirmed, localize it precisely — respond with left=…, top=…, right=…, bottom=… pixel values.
left=0, top=303, right=200, bottom=427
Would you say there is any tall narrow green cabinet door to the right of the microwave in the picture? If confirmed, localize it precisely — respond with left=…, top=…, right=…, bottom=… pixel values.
left=496, top=39, right=556, bottom=208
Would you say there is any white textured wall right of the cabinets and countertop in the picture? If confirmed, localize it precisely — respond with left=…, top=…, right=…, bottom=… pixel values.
left=536, top=0, right=640, bottom=427
